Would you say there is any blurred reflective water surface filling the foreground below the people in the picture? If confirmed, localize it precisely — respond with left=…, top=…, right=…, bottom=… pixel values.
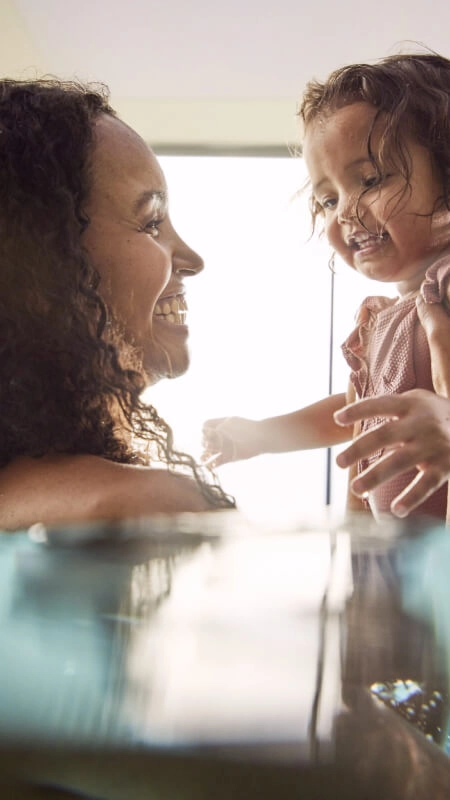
left=0, top=512, right=450, bottom=800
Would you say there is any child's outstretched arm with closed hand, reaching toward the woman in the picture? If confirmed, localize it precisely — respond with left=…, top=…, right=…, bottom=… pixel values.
left=203, top=394, right=352, bottom=467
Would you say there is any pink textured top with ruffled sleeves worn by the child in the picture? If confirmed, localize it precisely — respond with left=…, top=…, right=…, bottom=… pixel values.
left=342, top=252, right=450, bottom=519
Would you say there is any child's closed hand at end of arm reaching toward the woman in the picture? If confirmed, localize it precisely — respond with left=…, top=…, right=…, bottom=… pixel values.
left=202, top=417, right=261, bottom=467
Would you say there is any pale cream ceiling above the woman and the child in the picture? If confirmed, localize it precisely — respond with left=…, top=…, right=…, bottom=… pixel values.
left=0, top=0, right=450, bottom=151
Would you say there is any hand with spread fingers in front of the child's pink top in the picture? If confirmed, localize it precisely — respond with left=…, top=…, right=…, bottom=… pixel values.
left=334, top=389, right=450, bottom=517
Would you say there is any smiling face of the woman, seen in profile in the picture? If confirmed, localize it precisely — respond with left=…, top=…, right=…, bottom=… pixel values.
left=83, top=115, right=203, bottom=383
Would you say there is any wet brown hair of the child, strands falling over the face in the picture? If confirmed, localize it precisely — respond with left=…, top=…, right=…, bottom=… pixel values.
left=298, top=52, right=450, bottom=231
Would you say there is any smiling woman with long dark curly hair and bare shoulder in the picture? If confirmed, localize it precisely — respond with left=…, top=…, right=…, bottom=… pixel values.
left=0, top=80, right=234, bottom=530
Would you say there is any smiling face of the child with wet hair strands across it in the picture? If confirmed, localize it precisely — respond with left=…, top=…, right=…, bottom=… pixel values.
left=303, top=103, right=450, bottom=294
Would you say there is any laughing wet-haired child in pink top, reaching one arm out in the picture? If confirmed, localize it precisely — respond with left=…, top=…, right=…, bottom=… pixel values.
left=203, top=54, right=450, bottom=519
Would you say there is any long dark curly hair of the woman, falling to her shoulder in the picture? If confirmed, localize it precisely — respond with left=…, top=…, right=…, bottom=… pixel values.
left=0, top=78, right=235, bottom=507
